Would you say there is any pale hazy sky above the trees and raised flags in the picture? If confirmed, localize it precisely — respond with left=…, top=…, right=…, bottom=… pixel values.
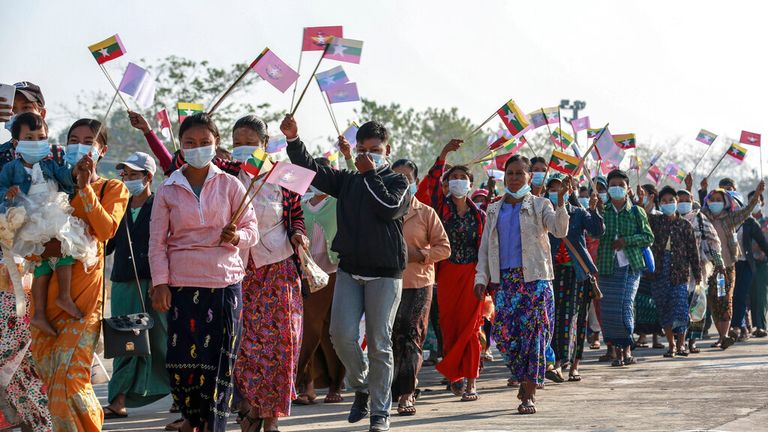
left=0, top=0, right=768, bottom=174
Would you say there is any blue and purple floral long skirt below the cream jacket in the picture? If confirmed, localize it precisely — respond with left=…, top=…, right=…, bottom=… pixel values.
left=493, top=268, right=554, bottom=384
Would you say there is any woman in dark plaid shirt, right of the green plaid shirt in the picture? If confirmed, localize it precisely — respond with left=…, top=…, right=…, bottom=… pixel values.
left=648, top=186, right=701, bottom=358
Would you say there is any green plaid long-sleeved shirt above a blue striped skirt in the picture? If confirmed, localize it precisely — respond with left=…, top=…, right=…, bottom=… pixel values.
left=597, top=200, right=653, bottom=275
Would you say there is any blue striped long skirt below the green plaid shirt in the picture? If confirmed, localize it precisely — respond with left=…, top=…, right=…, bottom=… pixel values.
left=600, top=265, right=641, bottom=348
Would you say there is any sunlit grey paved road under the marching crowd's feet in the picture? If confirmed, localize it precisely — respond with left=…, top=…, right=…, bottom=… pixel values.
left=96, top=339, right=768, bottom=432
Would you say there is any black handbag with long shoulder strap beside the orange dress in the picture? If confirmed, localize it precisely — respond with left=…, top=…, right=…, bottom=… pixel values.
left=101, top=186, right=155, bottom=359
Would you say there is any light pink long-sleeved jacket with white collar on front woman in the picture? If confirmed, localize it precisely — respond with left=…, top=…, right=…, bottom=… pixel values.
left=149, top=164, right=259, bottom=288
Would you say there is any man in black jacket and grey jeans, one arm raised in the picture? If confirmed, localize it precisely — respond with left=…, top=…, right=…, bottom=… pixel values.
left=280, top=115, right=410, bottom=431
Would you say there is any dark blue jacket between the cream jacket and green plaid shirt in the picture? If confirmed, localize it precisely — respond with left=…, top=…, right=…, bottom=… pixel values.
left=549, top=204, right=605, bottom=282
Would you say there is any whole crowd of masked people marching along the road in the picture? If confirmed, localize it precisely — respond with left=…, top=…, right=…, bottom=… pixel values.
left=0, top=82, right=768, bottom=432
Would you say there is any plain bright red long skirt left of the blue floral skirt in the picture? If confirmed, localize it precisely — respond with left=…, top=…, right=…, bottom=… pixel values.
left=437, top=261, right=483, bottom=382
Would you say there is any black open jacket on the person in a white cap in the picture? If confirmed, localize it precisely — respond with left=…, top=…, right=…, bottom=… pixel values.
left=107, top=195, right=155, bottom=282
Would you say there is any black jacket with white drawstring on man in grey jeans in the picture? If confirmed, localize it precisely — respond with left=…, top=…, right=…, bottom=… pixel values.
left=287, top=138, right=410, bottom=279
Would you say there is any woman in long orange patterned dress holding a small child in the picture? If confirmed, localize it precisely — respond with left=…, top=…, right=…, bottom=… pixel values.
left=31, top=119, right=128, bottom=431
